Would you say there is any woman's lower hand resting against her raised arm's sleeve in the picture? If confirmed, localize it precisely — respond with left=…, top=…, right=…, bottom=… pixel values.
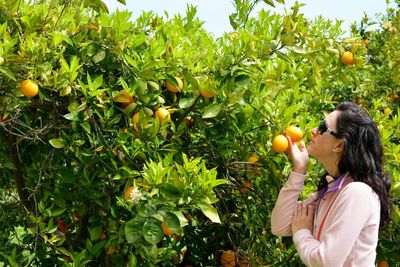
left=292, top=203, right=315, bottom=234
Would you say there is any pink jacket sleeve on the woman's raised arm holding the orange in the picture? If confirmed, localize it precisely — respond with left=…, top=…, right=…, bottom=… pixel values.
left=271, top=172, right=311, bottom=236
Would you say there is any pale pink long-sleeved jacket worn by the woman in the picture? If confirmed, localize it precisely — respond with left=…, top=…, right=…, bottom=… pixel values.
left=271, top=172, right=380, bottom=267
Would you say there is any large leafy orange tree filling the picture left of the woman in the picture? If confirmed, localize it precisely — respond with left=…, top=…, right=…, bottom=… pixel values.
left=0, top=0, right=400, bottom=266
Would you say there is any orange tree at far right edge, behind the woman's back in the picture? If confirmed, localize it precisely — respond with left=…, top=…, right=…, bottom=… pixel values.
left=352, top=1, right=400, bottom=266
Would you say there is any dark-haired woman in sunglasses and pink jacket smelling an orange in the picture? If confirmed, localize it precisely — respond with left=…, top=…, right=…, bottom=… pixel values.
left=271, top=102, right=391, bottom=267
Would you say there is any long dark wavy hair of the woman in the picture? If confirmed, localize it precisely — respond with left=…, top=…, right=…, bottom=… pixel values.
left=318, top=102, right=392, bottom=227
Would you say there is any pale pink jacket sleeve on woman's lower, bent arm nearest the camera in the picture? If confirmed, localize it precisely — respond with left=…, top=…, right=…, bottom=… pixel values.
left=293, top=182, right=379, bottom=267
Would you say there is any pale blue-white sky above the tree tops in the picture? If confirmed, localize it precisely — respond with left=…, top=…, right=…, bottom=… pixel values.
left=103, top=0, right=394, bottom=38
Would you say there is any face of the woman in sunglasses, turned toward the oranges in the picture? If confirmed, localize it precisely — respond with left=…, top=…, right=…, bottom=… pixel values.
left=307, top=110, right=341, bottom=161
